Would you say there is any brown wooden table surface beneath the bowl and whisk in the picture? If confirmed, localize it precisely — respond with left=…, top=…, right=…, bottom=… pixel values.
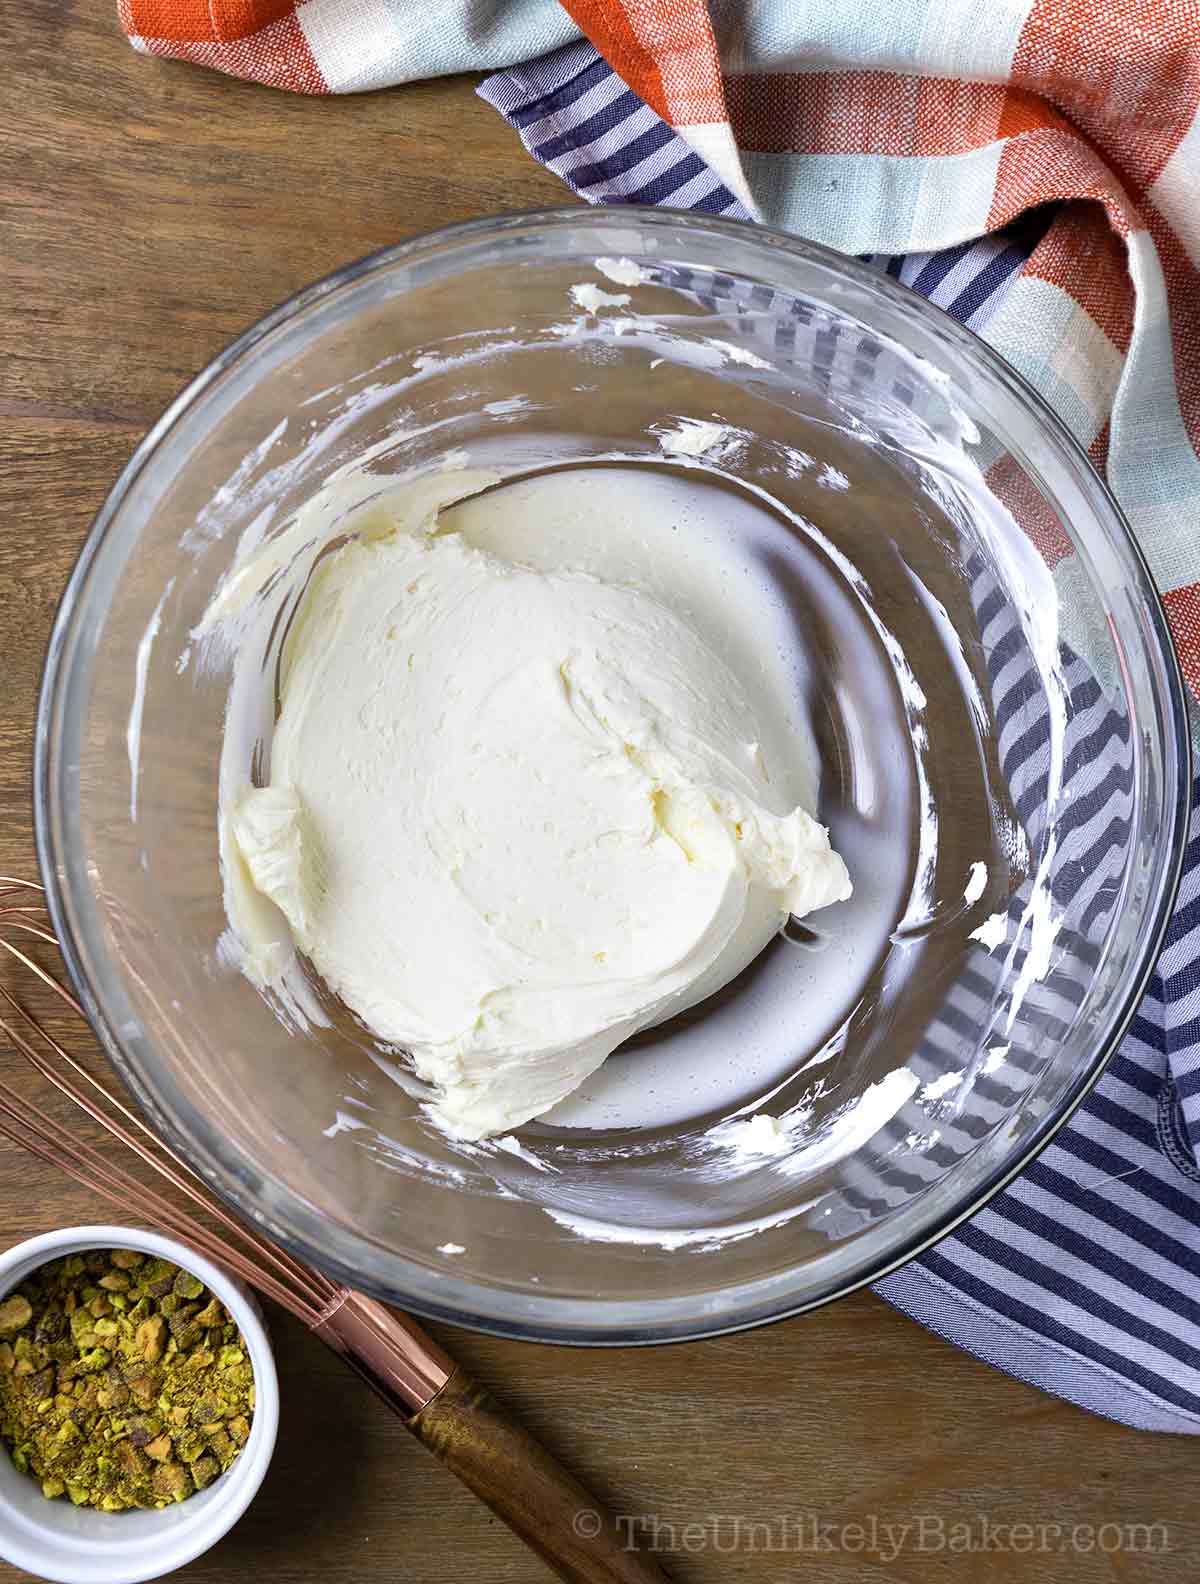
left=0, top=0, right=1200, bottom=1584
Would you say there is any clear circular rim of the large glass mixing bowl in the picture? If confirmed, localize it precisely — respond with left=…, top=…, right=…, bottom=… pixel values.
left=33, top=204, right=1192, bottom=1346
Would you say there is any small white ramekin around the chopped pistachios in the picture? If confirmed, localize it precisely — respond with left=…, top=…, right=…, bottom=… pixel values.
left=0, top=1226, right=279, bottom=1584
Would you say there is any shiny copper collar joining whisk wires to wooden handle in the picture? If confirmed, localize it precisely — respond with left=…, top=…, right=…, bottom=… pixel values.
left=312, top=1288, right=454, bottom=1418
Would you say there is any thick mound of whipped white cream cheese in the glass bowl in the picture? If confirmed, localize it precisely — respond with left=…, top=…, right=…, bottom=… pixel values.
left=222, top=469, right=850, bottom=1139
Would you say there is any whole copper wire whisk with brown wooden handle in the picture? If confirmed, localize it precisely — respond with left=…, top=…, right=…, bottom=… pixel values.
left=0, top=876, right=665, bottom=1584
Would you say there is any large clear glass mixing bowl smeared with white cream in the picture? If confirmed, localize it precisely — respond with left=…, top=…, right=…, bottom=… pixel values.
left=36, top=208, right=1187, bottom=1343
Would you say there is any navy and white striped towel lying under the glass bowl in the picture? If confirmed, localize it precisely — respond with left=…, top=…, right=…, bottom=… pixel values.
left=480, top=43, right=1200, bottom=1432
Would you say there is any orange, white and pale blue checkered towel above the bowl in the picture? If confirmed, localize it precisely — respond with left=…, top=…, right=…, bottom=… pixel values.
left=119, top=0, right=1200, bottom=697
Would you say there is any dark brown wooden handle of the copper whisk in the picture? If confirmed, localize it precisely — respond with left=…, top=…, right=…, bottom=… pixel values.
left=407, top=1369, right=677, bottom=1584
